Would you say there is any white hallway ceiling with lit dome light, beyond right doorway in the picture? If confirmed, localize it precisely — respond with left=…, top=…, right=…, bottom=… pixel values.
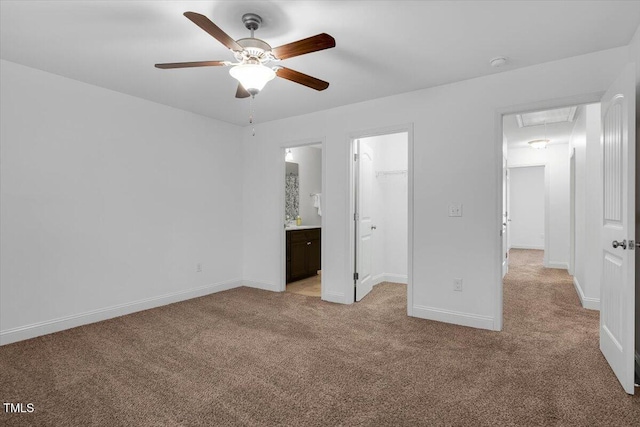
left=502, top=106, right=584, bottom=149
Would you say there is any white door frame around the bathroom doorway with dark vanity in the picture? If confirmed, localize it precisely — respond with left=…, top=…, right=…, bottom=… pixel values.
left=278, top=137, right=327, bottom=300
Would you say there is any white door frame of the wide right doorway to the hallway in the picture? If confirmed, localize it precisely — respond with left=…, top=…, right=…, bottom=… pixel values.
left=493, top=91, right=604, bottom=331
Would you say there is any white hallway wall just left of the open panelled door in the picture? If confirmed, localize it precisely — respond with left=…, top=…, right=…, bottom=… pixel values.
left=570, top=104, right=602, bottom=310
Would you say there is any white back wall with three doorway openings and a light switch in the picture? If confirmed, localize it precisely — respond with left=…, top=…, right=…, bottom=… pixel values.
left=243, top=47, right=629, bottom=328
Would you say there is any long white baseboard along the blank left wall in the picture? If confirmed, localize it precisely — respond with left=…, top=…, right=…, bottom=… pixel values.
left=0, top=279, right=242, bottom=345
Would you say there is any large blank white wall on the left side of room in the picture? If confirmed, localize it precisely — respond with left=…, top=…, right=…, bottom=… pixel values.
left=0, top=61, right=244, bottom=343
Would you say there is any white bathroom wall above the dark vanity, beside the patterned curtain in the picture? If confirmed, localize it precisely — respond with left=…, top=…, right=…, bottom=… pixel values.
left=288, top=147, right=322, bottom=225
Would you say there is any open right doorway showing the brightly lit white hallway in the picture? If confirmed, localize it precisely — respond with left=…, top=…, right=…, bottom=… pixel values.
left=503, top=103, right=602, bottom=310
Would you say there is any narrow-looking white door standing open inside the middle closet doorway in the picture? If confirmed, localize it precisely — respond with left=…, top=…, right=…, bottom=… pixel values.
left=355, top=140, right=375, bottom=301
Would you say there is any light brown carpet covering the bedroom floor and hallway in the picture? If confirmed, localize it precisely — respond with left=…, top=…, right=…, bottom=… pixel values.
left=0, top=251, right=640, bottom=426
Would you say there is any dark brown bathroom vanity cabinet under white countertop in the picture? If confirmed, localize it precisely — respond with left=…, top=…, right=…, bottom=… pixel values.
left=287, top=228, right=320, bottom=283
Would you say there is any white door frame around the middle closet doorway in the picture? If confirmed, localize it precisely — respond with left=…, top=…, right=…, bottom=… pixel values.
left=345, top=123, right=414, bottom=316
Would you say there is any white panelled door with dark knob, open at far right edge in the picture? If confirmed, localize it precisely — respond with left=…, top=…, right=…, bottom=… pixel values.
left=600, top=64, right=636, bottom=394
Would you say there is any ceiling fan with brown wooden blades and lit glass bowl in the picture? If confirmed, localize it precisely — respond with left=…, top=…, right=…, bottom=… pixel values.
left=156, top=12, right=336, bottom=98
